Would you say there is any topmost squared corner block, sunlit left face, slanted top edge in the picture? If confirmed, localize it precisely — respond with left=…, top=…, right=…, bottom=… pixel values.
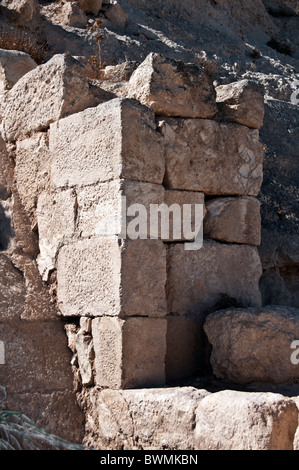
left=50, top=98, right=164, bottom=187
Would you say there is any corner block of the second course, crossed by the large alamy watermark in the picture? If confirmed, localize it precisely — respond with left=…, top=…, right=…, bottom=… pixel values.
left=77, top=180, right=204, bottom=241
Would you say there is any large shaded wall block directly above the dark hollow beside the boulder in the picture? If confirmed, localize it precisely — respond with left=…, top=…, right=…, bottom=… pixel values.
left=166, top=240, right=262, bottom=316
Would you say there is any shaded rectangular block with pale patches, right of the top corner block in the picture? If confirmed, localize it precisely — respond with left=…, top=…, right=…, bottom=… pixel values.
left=161, top=119, right=263, bottom=196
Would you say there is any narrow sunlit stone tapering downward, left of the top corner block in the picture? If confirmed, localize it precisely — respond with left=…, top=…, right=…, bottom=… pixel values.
left=15, top=132, right=50, bottom=225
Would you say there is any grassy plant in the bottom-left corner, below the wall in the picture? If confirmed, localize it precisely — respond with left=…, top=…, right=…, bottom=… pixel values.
left=0, top=410, right=85, bottom=450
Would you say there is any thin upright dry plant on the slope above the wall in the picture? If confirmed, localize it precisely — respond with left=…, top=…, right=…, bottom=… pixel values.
left=86, top=18, right=104, bottom=79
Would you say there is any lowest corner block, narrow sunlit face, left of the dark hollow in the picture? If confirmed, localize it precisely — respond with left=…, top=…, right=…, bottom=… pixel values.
left=92, top=317, right=166, bottom=389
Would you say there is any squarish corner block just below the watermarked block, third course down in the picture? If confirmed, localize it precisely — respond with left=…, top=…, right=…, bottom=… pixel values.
left=57, top=237, right=166, bottom=317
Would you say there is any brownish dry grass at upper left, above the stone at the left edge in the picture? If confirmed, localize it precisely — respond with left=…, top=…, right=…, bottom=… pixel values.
left=0, top=24, right=52, bottom=64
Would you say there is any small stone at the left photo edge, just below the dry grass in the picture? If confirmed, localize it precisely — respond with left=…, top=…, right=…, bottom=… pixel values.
left=0, top=49, right=37, bottom=92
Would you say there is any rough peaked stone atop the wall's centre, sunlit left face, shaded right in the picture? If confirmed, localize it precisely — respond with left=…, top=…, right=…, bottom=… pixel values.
left=128, top=53, right=217, bottom=118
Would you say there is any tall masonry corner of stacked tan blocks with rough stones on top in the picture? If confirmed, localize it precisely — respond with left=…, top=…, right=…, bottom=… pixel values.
left=7, top=54, right=263, bottom=389
